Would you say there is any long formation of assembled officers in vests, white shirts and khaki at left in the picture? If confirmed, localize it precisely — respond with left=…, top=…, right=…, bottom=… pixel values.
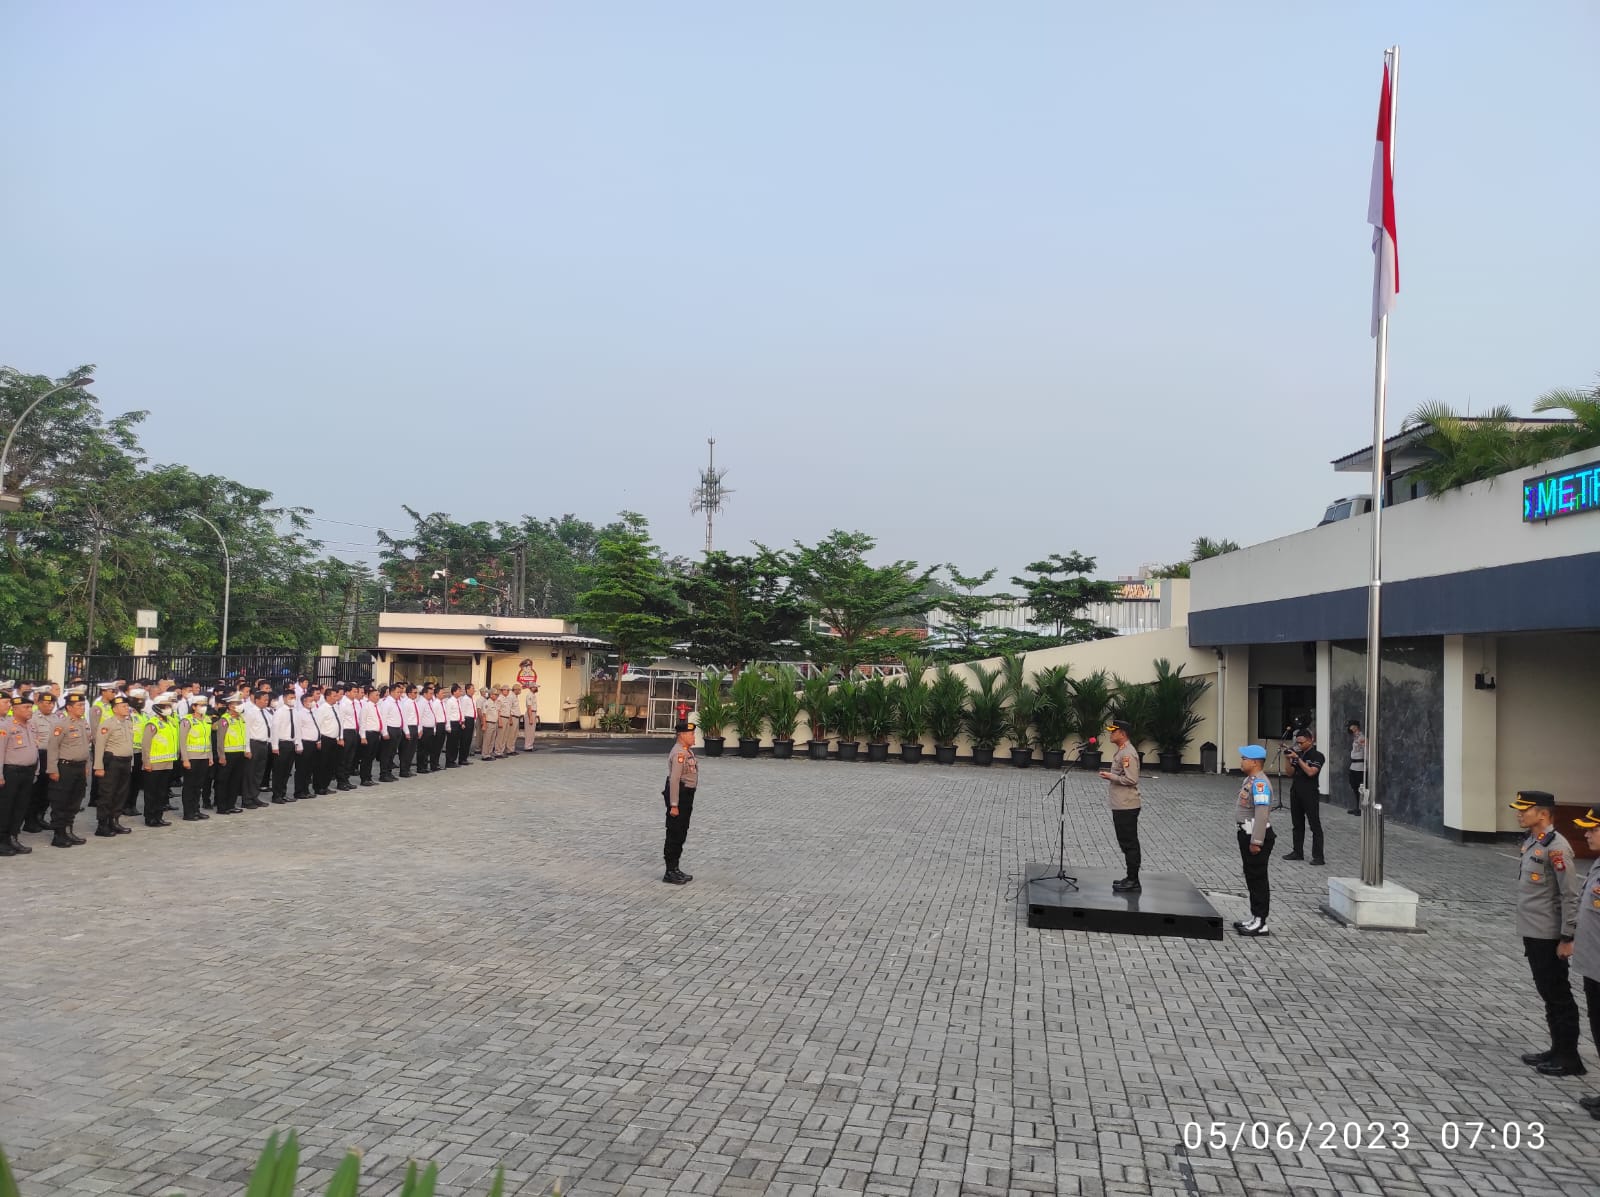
left=0, top=679, right=538, bottom=856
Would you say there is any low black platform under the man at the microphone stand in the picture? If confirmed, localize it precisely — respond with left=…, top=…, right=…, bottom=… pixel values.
left=1027, top=864, right=1222, bottom=939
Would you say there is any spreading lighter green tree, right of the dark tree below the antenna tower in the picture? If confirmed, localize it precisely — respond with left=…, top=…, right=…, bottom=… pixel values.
left=777, top=528, right=938, bottom=672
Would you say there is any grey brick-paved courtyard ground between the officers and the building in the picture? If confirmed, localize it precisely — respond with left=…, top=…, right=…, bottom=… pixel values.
left=0, top=746, right=1600, bottom=1197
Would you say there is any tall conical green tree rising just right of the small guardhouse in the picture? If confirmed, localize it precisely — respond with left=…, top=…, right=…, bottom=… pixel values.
left=578, top=510, right=682, bottom=704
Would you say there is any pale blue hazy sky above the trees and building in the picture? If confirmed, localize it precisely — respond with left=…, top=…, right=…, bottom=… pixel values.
left=0, top=0, right=1600, bottom=578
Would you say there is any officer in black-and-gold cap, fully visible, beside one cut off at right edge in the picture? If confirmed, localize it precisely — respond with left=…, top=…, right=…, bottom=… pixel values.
left=1510, top=789, right=1586, bottom=1077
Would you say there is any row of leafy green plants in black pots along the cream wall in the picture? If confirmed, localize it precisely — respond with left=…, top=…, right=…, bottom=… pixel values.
left=696, top=656, right=1211, bottom=770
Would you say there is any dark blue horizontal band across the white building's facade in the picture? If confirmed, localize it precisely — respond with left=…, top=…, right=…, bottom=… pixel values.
left=1189, top=552, right=1600, bottom=648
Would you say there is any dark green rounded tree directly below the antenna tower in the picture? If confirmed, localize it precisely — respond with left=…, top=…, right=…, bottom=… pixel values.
left=677, top=549, right=805, bottom=674
